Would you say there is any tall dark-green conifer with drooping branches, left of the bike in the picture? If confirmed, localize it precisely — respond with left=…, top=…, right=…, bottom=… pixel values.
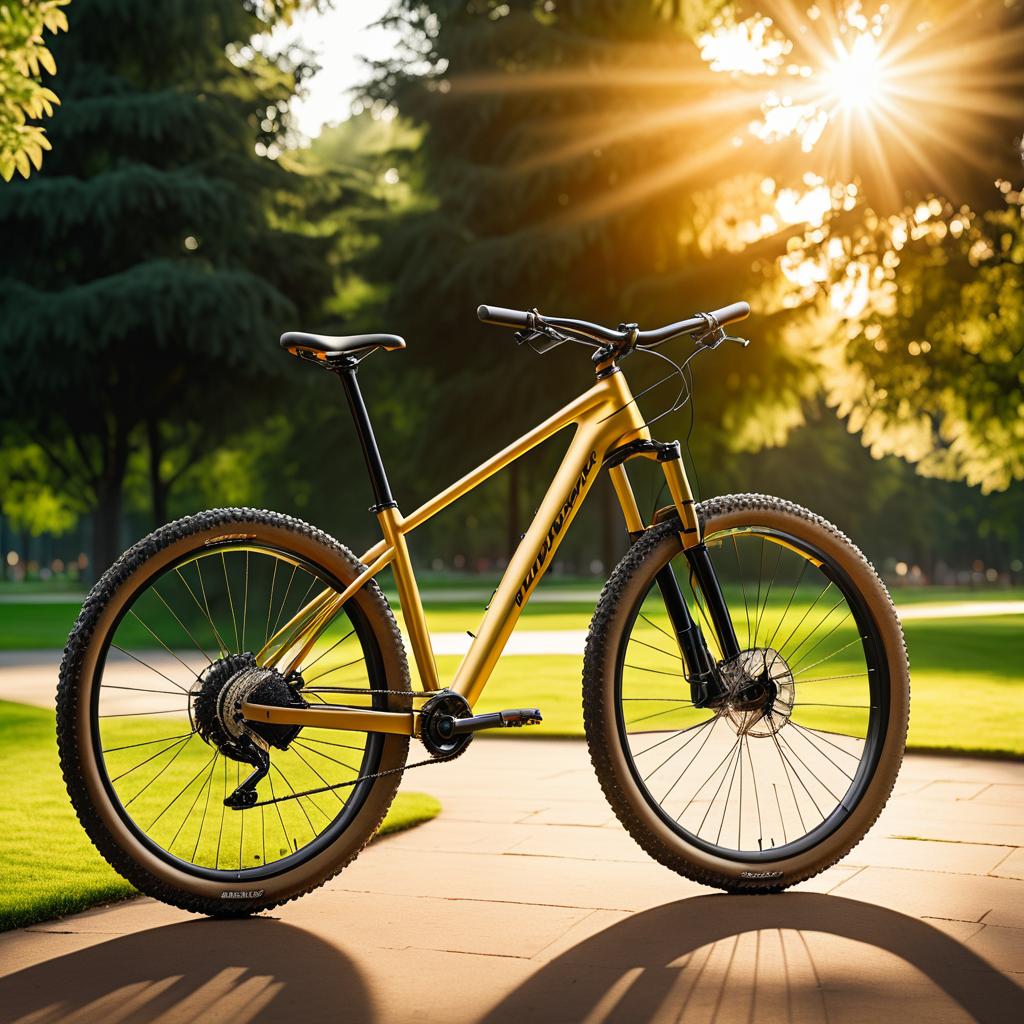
left=0, top=0, right=331, bottom=570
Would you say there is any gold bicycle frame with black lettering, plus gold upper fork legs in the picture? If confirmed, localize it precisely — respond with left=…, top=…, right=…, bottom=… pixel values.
left=242, top=360, right=700, bottom=735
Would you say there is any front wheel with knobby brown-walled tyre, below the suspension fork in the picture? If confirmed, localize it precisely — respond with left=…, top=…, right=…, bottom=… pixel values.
left=584, top=495, right=909, bottom=892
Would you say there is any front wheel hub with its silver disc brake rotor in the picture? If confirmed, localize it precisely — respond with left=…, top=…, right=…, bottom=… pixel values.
left=720, top=647, right=796, bottom=736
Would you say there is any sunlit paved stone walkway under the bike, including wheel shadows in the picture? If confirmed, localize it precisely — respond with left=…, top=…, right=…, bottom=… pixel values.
left=0, top=738, right=1024, bottom=1024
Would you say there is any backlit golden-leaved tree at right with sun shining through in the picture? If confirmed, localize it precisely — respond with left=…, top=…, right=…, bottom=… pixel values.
left=724, top=0, right=1024, bottom=492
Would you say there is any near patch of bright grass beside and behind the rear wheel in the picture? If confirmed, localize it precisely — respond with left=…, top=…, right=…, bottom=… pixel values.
left=0, top=701, right=440, bottom=931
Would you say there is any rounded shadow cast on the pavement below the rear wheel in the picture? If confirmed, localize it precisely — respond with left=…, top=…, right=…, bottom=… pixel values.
left=0, top=918, right=375, bottom=1024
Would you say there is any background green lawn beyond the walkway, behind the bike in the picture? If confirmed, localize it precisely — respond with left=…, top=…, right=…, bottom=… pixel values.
left=0, top=582, right=1024, bottom=756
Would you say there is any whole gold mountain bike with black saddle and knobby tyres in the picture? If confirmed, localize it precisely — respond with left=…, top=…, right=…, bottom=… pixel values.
left=57, top=303, right=909, bottom=915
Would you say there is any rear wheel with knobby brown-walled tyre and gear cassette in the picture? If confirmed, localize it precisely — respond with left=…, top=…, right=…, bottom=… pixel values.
left=57, top=509, right=411, bottom=915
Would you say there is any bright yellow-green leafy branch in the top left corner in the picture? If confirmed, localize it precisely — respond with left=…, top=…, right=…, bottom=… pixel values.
left=0, top=0, right=70, bottom=181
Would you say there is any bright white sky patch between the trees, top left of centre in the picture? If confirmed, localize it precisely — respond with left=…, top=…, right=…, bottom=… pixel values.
left=278, top=0, right=396, bottom=137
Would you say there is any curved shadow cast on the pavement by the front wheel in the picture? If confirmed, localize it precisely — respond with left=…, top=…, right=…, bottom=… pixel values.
left=483, top=893, right=1024, bottom=1024
